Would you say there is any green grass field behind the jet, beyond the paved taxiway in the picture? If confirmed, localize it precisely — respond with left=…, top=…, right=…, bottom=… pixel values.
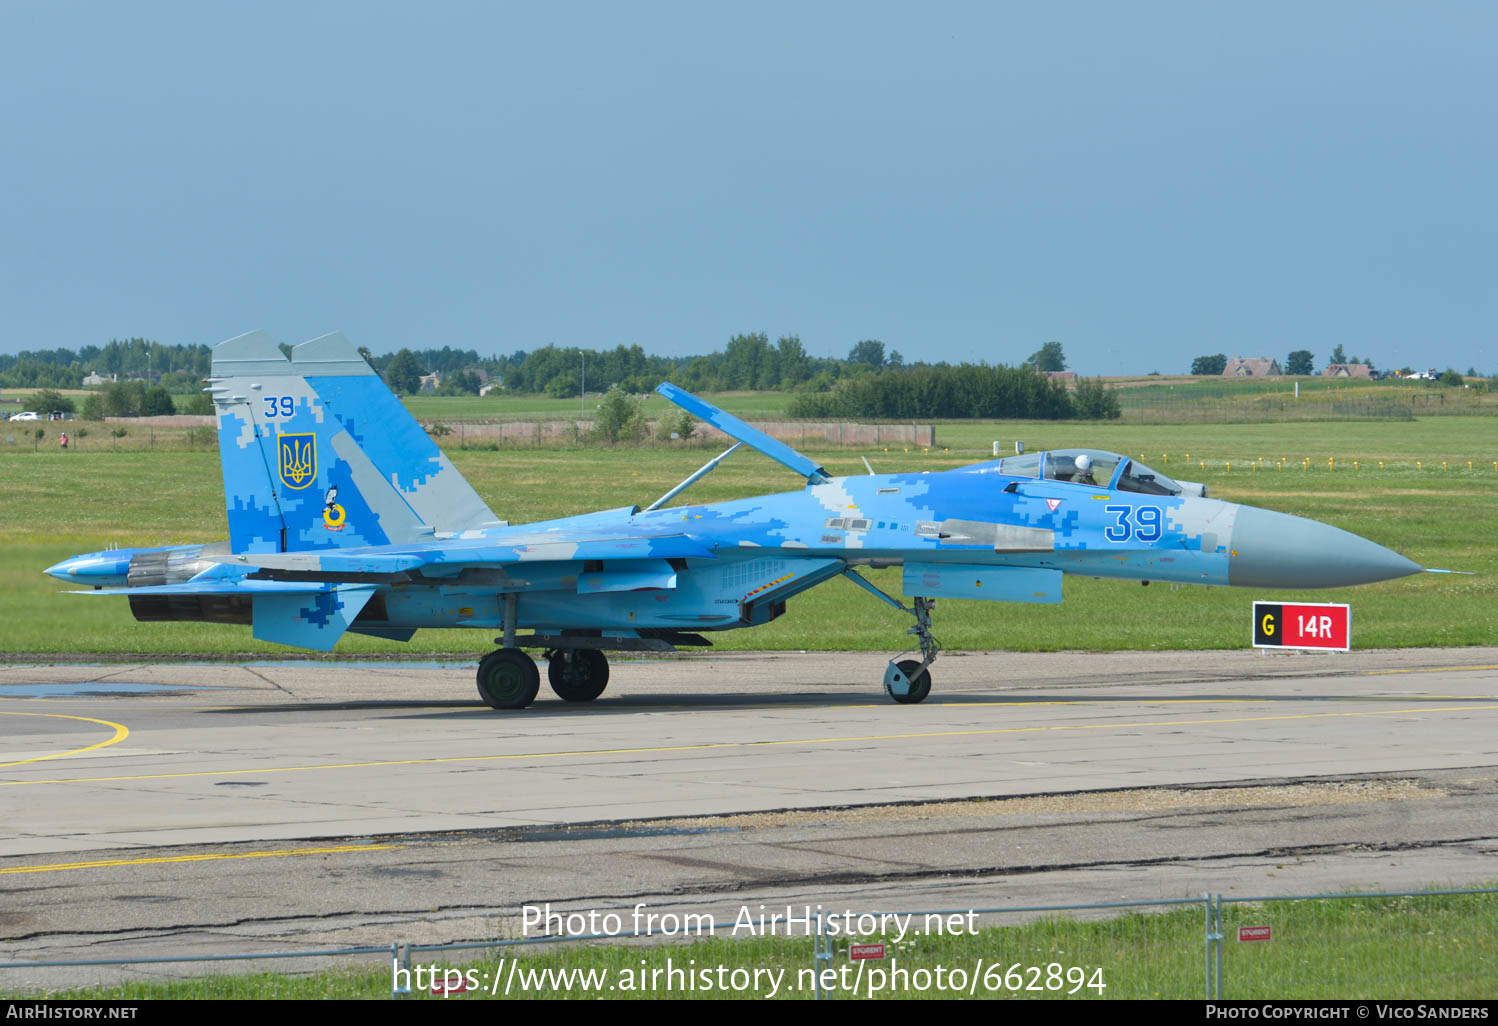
left=0, top=418, right=1498, bottom=656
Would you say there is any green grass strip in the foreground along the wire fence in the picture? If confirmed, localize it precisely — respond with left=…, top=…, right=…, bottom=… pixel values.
left=23, top=893, right=1498, bottom=1001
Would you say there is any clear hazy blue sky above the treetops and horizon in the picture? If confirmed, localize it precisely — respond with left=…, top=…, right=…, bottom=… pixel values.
left=0, top=0, right=1498, bottom=374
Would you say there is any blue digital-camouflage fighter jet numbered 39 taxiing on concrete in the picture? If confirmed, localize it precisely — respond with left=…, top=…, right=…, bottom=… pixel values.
left=46, top=333, right=1422, bottom=708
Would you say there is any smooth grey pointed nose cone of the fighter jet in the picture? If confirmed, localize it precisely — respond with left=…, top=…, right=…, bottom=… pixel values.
left=1227, top=506, right=1420, bottom=589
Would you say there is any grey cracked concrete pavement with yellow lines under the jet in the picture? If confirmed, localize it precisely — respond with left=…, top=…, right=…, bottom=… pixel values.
left=0, top=649, right=1498, bottom=989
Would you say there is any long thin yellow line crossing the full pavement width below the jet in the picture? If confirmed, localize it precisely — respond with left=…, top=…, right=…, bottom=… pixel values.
left=0, top=699, right=1498, bottom=788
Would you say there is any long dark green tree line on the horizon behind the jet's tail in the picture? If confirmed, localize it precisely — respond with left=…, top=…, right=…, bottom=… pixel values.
left=0, top=331, right=1119, bottom=419
